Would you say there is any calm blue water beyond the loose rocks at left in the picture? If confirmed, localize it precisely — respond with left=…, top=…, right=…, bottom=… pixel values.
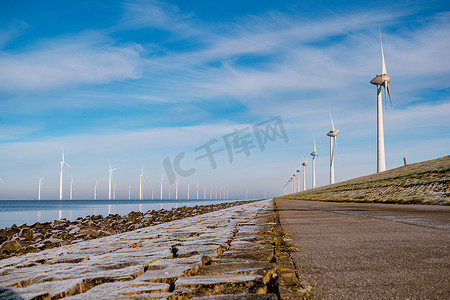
left=0, top=200, right=238, bottom=228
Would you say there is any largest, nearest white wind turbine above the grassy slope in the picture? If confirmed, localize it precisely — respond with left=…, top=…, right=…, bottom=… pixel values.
left=370, top=30, right=392, bottom=173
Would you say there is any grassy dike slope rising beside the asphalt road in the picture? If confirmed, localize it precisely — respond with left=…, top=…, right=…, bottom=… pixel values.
left=282, top=156, right=450, bottom=205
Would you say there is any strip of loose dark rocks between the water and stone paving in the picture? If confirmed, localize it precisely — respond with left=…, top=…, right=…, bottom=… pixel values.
left=0, top=201, right=253, bottom=259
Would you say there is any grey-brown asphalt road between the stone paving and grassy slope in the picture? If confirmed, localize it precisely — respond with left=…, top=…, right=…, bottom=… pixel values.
left=276, top=199, right=450, bottom=299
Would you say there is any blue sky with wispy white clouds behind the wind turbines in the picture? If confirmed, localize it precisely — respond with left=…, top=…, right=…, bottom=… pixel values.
left=0, top=0, right=450, bottom=199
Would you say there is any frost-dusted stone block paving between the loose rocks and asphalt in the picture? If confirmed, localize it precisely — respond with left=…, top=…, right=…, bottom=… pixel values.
left=0, top=200, right=284, bottom=299
